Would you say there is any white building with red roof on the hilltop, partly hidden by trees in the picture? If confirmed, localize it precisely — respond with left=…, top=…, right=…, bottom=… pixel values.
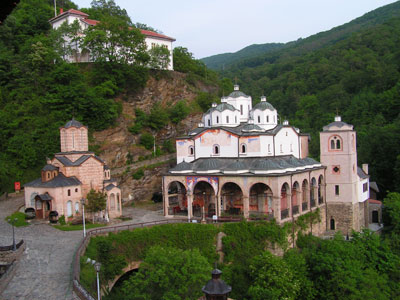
left=49, top=9, right=175, bottom=70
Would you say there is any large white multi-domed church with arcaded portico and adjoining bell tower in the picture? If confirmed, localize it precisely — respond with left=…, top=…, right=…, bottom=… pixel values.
left=163, top=85, right=376, bottom=234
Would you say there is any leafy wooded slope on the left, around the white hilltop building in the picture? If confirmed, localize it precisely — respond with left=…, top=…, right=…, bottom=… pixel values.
left=0, top=0, right=225, bottom=194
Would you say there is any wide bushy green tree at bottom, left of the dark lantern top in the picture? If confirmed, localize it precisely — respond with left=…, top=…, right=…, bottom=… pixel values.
left=122, top=246, right=211, bottom=300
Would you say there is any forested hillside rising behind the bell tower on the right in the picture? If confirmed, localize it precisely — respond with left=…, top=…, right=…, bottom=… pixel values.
left=219, top=2, right=400, bottom=195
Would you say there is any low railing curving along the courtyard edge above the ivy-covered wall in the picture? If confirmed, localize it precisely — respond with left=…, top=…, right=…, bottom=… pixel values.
left=72, top=219, right=187, bottom=300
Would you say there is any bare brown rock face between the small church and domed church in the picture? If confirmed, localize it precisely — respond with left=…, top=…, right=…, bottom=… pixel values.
left=90, top=72, right=217, bottom=202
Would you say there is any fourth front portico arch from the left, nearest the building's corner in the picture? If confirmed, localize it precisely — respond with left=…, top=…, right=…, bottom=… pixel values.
left=249, top=182, right=274, bottom=218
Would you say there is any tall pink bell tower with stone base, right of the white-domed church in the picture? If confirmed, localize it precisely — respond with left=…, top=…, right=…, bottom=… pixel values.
left=320, top=116, right=360, bottom=234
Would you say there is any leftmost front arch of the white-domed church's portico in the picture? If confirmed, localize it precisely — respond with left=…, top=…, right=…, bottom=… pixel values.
left=168, top=181, right=188, bottom=216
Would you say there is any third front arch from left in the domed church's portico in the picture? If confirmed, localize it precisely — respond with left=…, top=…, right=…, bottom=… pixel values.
left=221, top=182, right=243, bottom=215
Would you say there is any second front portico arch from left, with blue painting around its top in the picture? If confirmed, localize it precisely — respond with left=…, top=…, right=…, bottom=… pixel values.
left=193, top=181, right=216, bottom=217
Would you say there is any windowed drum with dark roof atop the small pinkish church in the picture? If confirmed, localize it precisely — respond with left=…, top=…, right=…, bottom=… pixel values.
left=60, top=119, right=89, bottom=152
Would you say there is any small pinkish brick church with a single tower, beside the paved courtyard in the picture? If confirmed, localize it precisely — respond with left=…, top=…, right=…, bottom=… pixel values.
left=24, top=119, right=122, bottom=218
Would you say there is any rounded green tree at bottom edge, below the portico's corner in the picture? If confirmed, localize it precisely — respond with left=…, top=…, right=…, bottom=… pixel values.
left=248, top=251, right=301, bottom=300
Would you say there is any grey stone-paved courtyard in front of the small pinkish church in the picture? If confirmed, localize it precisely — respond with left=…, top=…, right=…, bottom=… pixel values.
left=0, top=198, right=164, bottom=300
